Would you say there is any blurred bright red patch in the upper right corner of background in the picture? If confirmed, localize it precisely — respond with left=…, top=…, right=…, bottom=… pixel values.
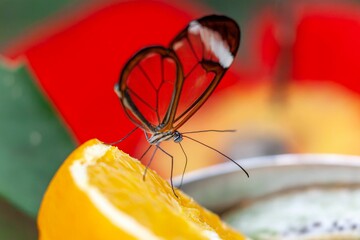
left=253, top=1, right=360, bottom=93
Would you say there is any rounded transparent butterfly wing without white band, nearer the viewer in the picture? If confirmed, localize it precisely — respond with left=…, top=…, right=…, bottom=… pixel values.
left=115, top=46, right=183, bottom=133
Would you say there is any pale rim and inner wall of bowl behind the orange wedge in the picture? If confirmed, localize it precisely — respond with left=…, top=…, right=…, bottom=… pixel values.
left=173, top=154, right=360, bottom=213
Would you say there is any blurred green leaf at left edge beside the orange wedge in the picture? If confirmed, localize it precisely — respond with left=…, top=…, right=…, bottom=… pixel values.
left=0, top=59, right=75, bottom=217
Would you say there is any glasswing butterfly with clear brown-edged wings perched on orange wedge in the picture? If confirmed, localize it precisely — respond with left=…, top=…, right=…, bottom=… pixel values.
left=115, top=15, right=249, bottom=194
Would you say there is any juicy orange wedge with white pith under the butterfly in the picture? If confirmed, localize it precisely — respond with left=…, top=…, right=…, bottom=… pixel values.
left=38, top=139, right=245, bottom=240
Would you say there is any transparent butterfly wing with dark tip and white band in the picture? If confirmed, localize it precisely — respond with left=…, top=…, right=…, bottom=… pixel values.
left=170, top=15, right=240, bottom=130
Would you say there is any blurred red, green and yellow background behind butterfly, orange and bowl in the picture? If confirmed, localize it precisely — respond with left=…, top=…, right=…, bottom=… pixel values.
left=0, top=0, right=360, bottom=240
